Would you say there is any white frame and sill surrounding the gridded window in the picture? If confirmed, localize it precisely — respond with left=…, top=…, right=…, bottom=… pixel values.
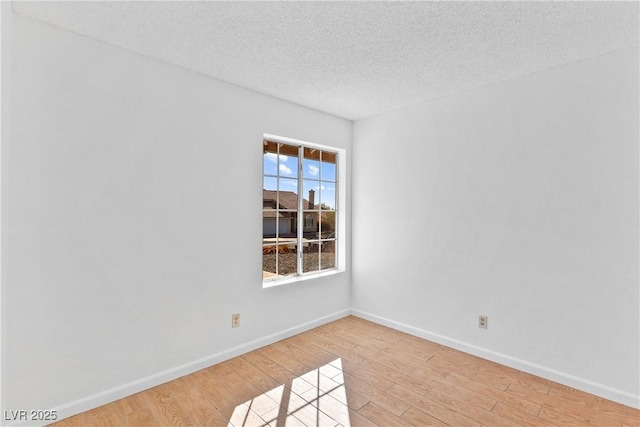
left=260, top=133, right=346, bottom=288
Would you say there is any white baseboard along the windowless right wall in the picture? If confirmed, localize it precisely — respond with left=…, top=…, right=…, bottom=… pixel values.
left=351, top=309, right=640, bottom=409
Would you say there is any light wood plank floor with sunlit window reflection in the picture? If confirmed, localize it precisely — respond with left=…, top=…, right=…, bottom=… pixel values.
left=56, top=316, right=640, bottom=427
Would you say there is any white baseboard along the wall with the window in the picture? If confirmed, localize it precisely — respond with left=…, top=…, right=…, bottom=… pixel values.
left=17, top=309, right=351, bottom=427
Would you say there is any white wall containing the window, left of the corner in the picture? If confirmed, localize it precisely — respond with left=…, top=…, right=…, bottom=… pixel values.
left=2, top=10, right=352, bottom=415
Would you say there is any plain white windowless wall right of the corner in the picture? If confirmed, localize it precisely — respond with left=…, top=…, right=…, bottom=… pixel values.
left=352, top=49, right=640, bottom=406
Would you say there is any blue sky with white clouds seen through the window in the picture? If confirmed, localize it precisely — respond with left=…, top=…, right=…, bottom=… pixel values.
left=263, top=153, right=336, bottom=209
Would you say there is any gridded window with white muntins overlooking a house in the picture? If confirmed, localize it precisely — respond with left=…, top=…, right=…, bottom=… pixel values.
left=262, top=139, right=338, bottom=282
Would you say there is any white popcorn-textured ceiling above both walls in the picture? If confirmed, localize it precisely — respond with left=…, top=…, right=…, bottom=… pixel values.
left=13, top=2, right=639, bottom=120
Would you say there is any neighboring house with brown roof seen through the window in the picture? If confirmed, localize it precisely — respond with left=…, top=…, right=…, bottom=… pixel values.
left=262, top=190, right=318, bottom=237
